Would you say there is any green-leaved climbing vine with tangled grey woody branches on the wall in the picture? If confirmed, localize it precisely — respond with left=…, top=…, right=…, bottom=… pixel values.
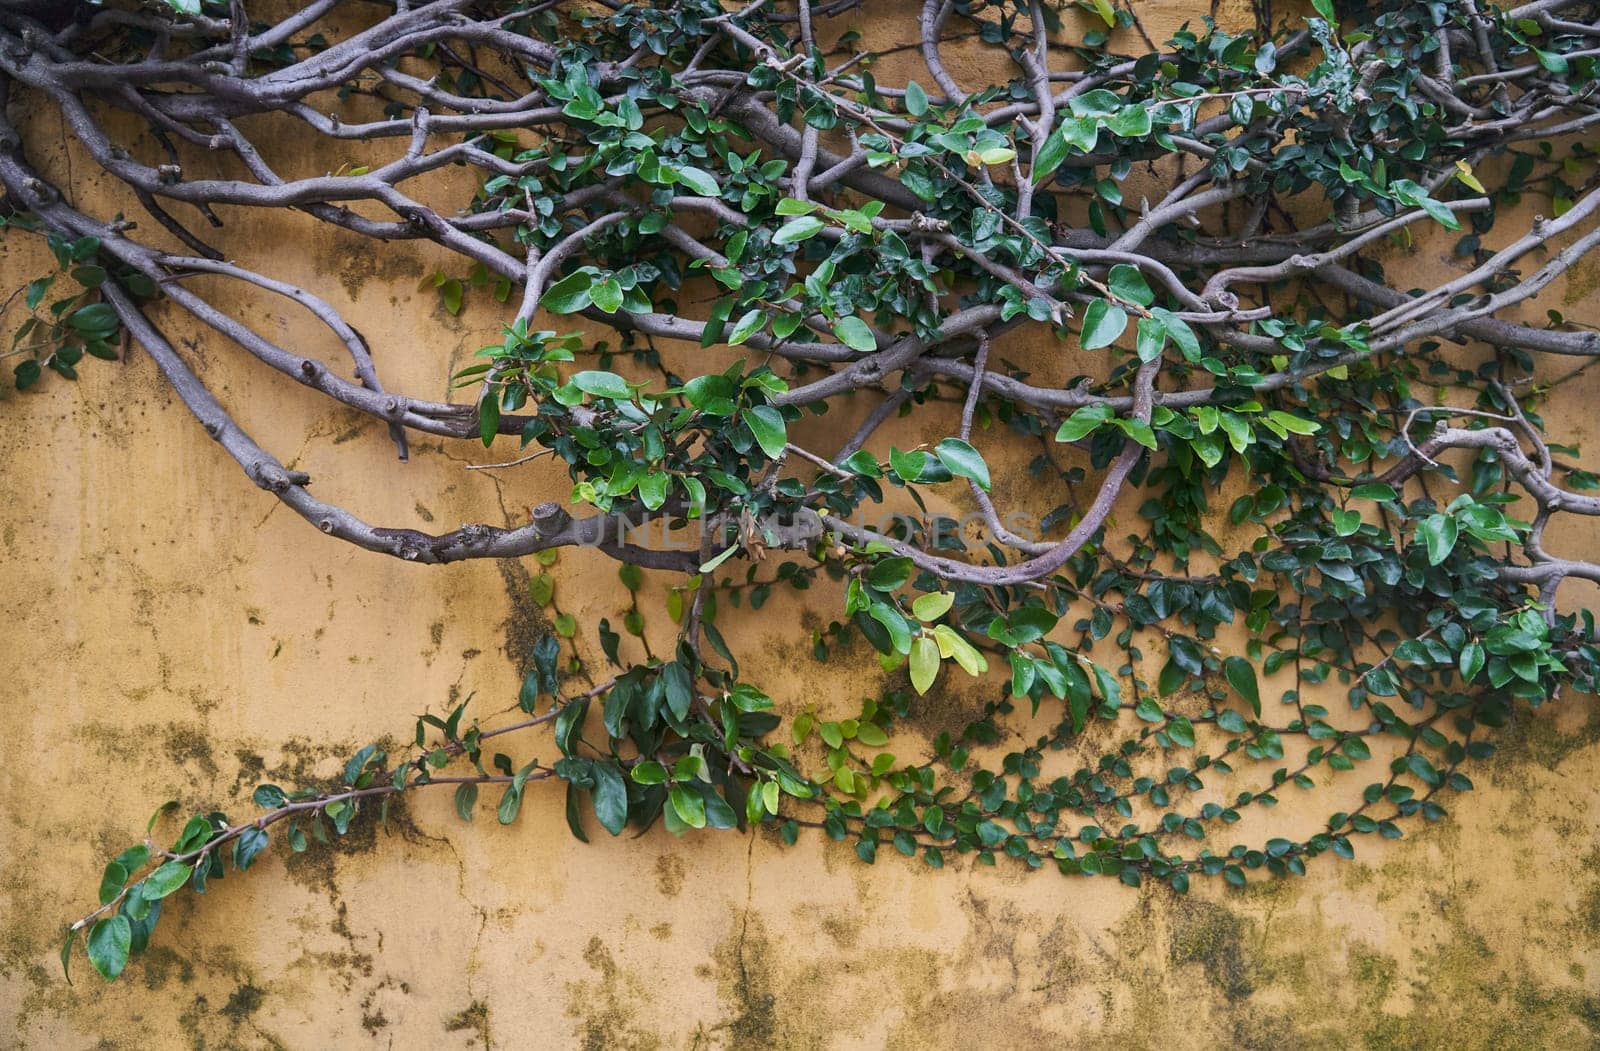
left=0, top=0, right=1600, bottom=979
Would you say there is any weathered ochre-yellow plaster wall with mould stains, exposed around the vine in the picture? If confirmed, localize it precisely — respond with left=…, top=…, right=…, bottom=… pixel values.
left=0, top=3, right=1600, bottom=1048
